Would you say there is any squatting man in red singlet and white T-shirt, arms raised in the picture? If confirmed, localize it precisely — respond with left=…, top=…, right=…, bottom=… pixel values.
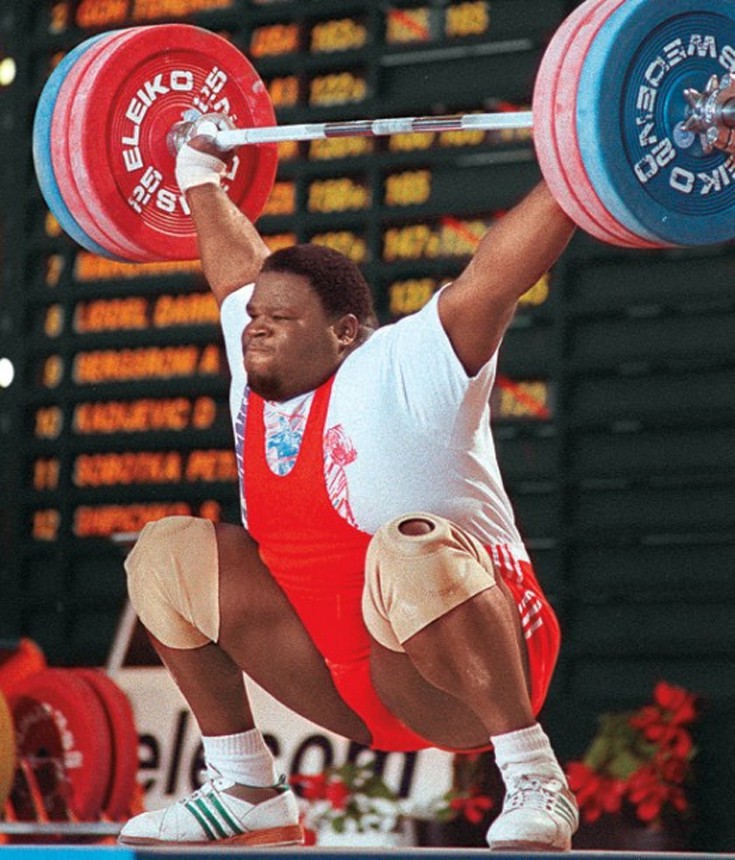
left=120, top=117, right=578, bottom=850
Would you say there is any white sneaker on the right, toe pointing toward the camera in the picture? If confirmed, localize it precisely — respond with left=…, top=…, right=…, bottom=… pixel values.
left=487, top=775, right=579, bottom=851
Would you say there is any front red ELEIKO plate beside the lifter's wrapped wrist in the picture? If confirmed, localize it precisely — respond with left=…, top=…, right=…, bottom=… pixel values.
left=71, top=24, right=278, bottom=260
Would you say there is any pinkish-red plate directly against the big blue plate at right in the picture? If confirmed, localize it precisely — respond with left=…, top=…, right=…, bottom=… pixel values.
left=554, top=0, right=661, bottom=248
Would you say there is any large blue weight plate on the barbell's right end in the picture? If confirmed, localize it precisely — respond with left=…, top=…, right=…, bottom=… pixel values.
left=577, top=0, right=735, bottom=245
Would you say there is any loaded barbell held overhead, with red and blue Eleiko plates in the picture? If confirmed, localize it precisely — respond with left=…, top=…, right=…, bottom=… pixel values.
left=33, top=0, right=735, bottom=262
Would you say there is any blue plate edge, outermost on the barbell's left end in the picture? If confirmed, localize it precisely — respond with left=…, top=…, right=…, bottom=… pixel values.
left=33, top=33, right=119, bottom=255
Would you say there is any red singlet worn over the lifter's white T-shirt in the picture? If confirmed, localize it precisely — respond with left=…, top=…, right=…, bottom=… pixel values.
left=243, top=377, right=558, bottom=752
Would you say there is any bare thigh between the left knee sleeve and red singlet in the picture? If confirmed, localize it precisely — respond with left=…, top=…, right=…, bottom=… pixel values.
left=216, top=525, right=370, bottom=744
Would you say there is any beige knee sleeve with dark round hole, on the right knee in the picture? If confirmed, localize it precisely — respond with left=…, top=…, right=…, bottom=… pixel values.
left=362, top=513, right=496, bottom=651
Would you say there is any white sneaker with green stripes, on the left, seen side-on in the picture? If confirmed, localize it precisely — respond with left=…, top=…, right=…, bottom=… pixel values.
left=118, top=776, right=304, bottom=846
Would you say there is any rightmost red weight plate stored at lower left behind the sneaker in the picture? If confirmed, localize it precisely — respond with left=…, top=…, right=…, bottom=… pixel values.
left=74, top=669, right=138, bottom=821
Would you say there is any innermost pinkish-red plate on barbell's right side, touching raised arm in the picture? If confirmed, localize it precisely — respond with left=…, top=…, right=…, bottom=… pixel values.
left=533, top=0, right=638, bottom=247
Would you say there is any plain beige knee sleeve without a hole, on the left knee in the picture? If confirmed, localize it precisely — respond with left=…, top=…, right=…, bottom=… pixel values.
left=125, top=517, right=219, bottom=648
